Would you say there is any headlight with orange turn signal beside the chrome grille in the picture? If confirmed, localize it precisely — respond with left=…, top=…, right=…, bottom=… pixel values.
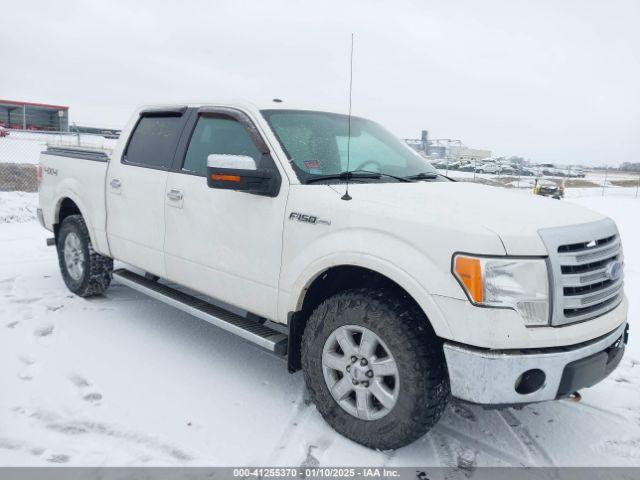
left=453, top=255, right=549, bottom=326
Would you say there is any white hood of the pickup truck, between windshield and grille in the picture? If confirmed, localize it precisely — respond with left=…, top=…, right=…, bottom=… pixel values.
left=340, top=182, right=604, bottom=255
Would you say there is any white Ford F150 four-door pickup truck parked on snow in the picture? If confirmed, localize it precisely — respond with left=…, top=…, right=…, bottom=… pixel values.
left=38, top=101, right=628, bottom=449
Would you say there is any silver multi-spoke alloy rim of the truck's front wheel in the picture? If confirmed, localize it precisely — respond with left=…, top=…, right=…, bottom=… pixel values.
left=322, top=325, right=400, bottom=421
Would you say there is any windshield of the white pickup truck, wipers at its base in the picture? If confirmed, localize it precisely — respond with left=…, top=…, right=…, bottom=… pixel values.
left=262, top=110, right=437, bottom=183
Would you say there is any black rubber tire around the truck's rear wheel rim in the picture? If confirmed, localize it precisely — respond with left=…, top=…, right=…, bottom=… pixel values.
left=56, top=215, right=113, bottom=297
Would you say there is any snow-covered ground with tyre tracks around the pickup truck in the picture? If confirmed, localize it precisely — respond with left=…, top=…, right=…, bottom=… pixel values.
left=0, top=189, right=640, bottom=466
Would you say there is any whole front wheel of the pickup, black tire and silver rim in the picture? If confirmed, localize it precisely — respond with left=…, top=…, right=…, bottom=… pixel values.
left=302, top=289, right=449, bottom=450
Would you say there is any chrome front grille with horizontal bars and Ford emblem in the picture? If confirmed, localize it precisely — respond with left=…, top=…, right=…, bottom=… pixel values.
left=538, top=219, right=624, bottom=325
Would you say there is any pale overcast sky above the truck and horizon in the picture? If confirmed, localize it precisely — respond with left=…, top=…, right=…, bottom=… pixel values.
left=0, top=0, right=640, bottom=164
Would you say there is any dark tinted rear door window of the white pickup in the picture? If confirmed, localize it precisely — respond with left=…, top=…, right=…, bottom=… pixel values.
left=123, top=115, right=184, bottom=170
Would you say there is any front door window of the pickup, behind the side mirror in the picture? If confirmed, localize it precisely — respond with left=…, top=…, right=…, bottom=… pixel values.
left=182, top=116, right=262, bottom=176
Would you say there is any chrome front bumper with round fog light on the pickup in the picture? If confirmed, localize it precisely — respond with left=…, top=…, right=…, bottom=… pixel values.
left=444, top=322, right=628, bottom=405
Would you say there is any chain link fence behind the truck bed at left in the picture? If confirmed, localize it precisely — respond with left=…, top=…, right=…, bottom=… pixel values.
left=0, top=129, right=117, bottom=192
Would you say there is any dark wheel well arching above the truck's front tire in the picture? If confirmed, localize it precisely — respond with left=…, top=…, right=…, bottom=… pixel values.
left=288, top=265, right=431, bottom=373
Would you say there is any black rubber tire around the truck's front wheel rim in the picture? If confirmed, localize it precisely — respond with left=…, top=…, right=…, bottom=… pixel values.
left=302, top=289, right=449, bottom=450
